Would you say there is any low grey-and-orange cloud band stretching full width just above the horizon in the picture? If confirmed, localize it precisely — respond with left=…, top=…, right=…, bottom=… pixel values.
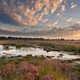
left=0, top=21, right=80, bottom=38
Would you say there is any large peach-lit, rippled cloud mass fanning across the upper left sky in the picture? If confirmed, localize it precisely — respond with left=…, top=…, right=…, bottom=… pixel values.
left=1, top=0, right=62, bottom=26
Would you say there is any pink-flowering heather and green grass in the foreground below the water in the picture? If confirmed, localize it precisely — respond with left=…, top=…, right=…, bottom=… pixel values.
left=0, top=55, right=80, bottom=80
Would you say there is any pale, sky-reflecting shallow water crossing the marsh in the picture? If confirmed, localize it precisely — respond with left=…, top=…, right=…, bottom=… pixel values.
left=0, top=45, right=80, bottom=60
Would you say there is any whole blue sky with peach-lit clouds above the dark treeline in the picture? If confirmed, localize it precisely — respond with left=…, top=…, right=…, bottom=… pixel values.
left=0, top=0, right=80, bottom=39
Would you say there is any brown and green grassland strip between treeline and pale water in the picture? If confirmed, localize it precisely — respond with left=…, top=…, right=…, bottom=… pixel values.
left=0, top=40, right=80, bottom=55
